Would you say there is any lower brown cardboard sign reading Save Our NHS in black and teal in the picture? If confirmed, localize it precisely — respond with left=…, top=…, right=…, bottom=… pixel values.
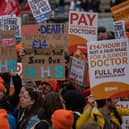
left=23, top=48, right=65, bottom=80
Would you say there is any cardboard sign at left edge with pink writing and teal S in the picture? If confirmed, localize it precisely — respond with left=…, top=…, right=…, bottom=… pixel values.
left=0, top=30, right=17, bottom=73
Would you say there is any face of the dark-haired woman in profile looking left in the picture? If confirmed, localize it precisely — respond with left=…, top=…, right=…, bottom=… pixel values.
left=19, top=87, right=35, bottom=108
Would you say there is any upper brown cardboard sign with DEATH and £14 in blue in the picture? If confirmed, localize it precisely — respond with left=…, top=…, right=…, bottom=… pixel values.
left=21, top=24, right=67, bottom=49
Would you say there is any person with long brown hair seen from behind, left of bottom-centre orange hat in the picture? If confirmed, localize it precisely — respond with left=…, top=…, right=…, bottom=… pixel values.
left=34, top=92, right=65, bottom=129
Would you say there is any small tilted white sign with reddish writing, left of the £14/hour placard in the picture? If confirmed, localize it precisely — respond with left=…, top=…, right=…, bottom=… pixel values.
left=69, top=57, right=87, bottom=86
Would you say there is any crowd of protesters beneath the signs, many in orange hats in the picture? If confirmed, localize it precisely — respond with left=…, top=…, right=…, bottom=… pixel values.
left=0, top=0, right=129, bottom=129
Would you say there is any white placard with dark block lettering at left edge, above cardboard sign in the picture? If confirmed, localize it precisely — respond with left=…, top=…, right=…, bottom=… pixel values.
left=0, top=15, right=21, bottom=38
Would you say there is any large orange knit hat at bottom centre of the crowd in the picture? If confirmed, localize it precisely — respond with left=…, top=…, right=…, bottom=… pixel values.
left=51, top=109, right=74, bottom=129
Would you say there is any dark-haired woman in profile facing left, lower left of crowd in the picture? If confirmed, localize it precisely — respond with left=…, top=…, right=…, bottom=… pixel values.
left=17, top=83, right=42, bottom=129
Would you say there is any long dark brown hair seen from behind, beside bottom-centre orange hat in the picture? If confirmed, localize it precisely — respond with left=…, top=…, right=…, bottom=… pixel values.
left=42, top=91, right=63, bottom=123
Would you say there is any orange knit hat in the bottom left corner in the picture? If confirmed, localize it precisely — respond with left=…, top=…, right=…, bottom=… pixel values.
left=0, top=109, right=10, bottom=129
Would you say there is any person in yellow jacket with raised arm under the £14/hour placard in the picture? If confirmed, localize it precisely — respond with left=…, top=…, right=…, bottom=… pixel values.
left=76, top=99, right=129, bottom=129
